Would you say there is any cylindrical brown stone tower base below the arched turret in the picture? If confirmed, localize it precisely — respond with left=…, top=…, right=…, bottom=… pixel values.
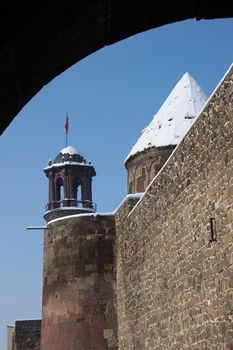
left=41, top=214, right=117, bottom=350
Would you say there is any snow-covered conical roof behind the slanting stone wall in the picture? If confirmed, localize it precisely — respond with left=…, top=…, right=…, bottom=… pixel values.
left=125, top=73, right=208, bottom=161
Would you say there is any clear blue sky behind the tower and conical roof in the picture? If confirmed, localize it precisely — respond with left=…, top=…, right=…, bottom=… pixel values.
left=0, top=19, right=233, bottom=350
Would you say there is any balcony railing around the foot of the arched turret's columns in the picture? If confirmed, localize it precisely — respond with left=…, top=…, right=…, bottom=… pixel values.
left=46, top=198, right=97, bottom=212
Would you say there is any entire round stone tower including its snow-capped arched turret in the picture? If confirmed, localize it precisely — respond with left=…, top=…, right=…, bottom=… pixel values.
left=40, top=146, right=109, bottom=350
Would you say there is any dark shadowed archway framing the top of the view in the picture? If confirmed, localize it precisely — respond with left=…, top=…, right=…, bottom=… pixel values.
left=0, top=0, right=233, bottom=134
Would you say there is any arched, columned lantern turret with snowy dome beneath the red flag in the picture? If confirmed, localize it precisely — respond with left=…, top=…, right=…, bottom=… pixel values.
left=44, top=146, right=96, bottom=222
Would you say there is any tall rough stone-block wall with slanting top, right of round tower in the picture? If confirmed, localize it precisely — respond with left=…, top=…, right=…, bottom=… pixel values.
left=115, top=68, right=233, bottom=350
